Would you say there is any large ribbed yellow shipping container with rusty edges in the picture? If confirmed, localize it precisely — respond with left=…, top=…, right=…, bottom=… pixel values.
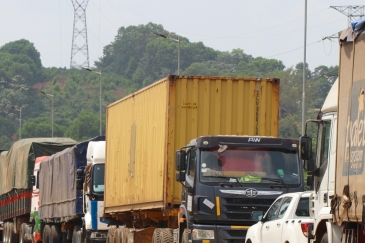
left=105, top=75, right=280, bottom=213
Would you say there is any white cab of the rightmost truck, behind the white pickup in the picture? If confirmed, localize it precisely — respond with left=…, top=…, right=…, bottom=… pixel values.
left=298, top=80, right=341, bottom=242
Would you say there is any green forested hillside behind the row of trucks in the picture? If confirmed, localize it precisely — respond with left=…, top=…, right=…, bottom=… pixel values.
left=0, top=23, right=338, bottom=149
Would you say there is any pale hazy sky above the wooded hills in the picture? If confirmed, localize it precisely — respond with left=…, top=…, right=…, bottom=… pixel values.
left=0, top=0, right=364, bottom=71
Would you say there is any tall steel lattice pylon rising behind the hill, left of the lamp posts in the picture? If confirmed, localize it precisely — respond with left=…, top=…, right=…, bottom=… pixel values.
left=70, top=0, right=90, bottom=68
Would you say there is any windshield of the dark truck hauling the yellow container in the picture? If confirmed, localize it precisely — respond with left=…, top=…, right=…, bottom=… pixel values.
left=200, top=147, right=300, bottom=184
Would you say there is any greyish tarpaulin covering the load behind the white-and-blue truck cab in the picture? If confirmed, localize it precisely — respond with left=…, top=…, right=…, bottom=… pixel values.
left=39, top=136, right=105, bottom=222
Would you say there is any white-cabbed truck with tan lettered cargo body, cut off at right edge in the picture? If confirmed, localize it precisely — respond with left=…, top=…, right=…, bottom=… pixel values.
left=300, top=21, right=365, bottom=243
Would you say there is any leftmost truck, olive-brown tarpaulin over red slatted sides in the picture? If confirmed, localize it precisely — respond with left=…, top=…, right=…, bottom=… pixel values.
left=0, top=138, right=76, bottom=243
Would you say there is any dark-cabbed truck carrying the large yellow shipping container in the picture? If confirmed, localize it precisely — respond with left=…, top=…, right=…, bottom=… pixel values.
left=104, top=75, right=304, bottom=243
